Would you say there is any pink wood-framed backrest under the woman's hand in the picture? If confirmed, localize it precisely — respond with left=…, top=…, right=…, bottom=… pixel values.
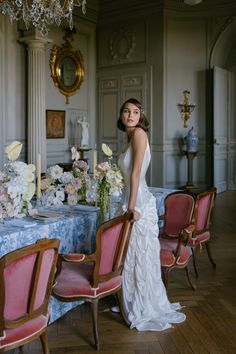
left=93, top=214, right=132, bottom=287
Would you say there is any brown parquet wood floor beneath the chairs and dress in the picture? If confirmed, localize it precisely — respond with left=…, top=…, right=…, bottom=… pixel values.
left=9, top=192, right=236, bottom=354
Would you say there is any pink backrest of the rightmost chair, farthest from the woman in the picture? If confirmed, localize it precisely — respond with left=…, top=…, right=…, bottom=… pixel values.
left=194, top=190, right=216, bottom=234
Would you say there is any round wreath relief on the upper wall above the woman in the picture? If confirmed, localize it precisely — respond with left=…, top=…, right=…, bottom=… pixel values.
left=109, top=28, right=135, bottom=64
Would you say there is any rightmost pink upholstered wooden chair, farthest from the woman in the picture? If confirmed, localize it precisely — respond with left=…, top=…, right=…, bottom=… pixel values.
left=187, top=188, right=216, bottom=277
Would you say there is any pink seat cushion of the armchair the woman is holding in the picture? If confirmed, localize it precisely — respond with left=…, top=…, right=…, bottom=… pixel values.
left=53, top=262, right=122, bottom=299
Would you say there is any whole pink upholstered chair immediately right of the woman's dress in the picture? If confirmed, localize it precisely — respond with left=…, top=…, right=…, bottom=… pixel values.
left=160, top=192, right=195, bottom=289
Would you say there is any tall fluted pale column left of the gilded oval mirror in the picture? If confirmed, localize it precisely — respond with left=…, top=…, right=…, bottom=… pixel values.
left=20, top=35, right=51, bottom=172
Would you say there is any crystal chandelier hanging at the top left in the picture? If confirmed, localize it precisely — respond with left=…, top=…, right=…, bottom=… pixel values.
left=0, top=0, right=86, bottom=36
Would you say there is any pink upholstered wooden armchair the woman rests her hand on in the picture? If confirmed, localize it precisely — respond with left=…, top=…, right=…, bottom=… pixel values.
left=52, top=215, right=131, bottom=349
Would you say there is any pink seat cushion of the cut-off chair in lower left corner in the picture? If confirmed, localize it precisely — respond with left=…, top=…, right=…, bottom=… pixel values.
left=0, top=315, right=49, bottom=349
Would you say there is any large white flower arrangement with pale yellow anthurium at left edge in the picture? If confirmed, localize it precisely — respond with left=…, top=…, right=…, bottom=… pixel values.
left=0, top=141, right=35, bottom=221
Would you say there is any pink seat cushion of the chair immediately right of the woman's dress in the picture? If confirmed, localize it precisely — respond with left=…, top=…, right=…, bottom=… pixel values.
left=160, top=239, right=192, bottom=267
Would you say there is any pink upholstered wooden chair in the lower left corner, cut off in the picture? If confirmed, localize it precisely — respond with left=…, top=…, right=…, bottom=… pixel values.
left=0, top=239, right=59, bottom=354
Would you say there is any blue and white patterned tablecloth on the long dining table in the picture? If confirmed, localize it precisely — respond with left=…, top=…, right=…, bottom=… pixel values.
left=0, top=188, right=173, bottom=322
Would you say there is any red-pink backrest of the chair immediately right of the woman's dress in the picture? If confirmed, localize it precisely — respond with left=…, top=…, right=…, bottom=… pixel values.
left=163, top=192, right=195, bottom=237
